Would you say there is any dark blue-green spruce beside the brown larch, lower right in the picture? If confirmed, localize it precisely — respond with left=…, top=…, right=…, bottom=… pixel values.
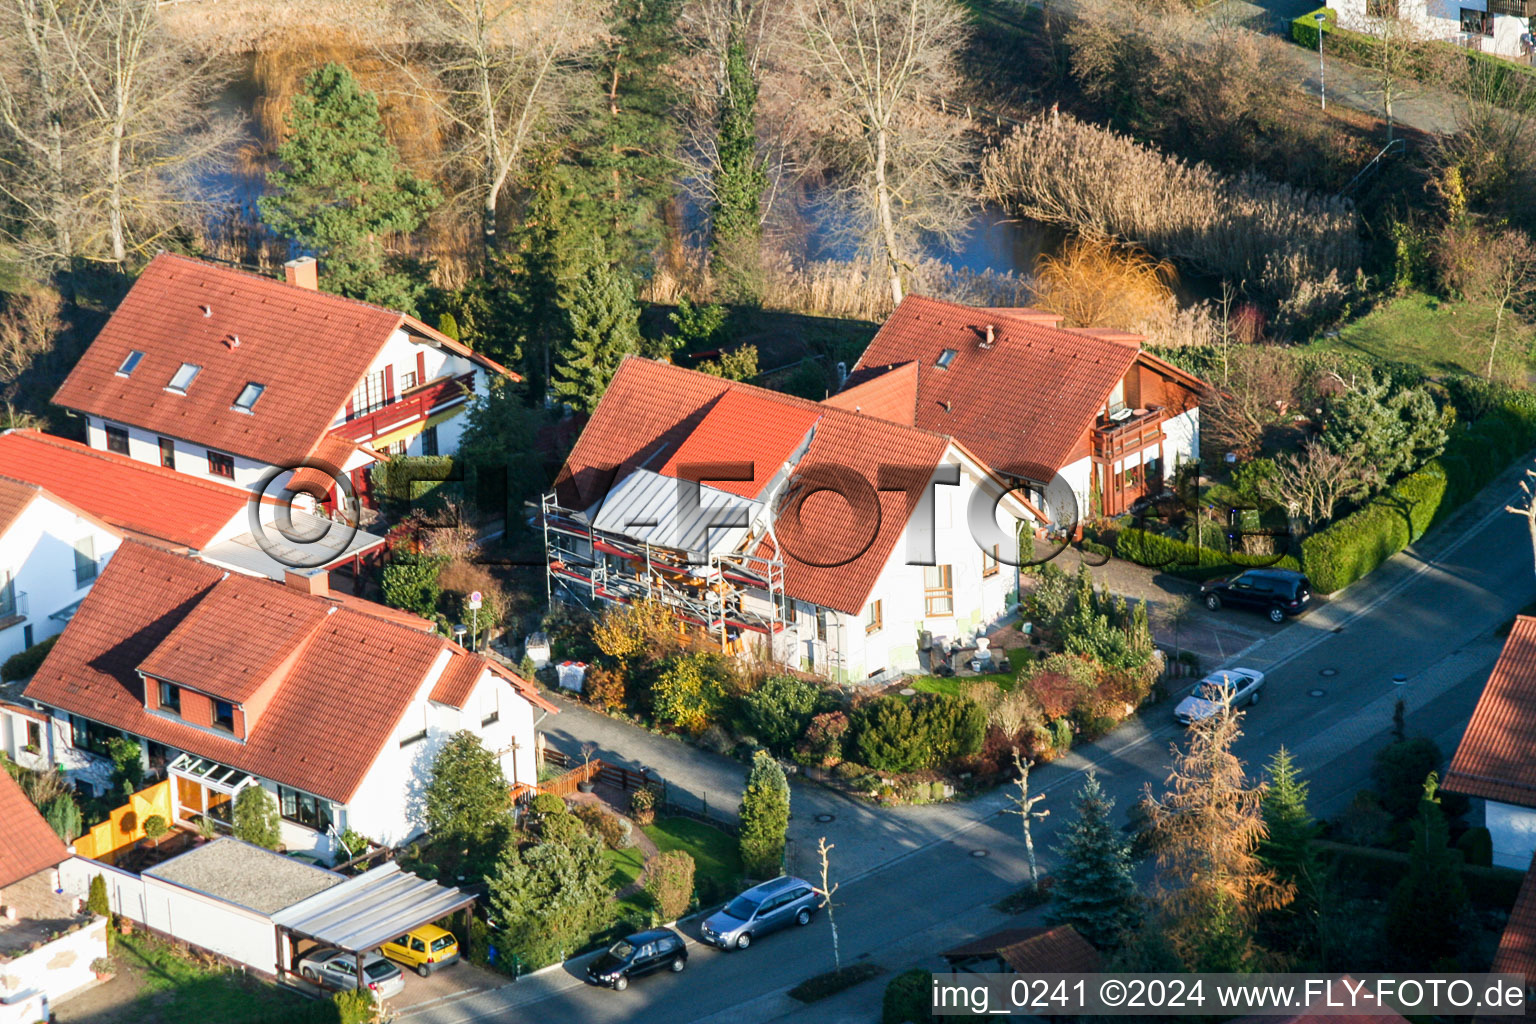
left=1049, top=772, right=1141, bottom=950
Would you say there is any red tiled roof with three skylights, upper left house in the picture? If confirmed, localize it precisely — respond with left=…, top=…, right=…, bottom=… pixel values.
left=54, top=253, right=516, bottom=467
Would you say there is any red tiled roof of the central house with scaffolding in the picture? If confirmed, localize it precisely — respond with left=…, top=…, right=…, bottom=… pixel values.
left=554, top=356, right=949, bottom=614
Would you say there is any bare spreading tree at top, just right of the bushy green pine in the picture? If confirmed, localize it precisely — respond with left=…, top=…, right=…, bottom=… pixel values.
left=382, top=0, right=607, bottom=250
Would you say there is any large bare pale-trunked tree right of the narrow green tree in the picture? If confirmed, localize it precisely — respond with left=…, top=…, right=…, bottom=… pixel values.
left=800, top=0, right=974, bottom=304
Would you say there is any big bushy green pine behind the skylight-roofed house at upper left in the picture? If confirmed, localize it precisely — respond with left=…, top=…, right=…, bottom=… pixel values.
left=258, top=63, right=442, bottom=313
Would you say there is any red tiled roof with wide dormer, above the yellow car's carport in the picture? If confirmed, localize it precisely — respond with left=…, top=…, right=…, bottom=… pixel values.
left=26, top=542, right=548, bottom=801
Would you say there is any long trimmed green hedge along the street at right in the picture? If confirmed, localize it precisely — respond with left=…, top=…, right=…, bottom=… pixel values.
left=1301, top=395, right=1536, bottom=594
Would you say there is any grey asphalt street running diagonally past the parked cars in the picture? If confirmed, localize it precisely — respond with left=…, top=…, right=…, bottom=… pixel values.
left=401, top=471, right=1536, bottom=1024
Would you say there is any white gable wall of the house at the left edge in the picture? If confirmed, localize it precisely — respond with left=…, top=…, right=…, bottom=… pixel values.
left=0, top=496, right=121, bottom=660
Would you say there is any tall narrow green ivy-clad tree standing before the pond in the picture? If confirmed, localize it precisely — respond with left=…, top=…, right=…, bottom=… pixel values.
left=710, top=25, right=768, bottom=302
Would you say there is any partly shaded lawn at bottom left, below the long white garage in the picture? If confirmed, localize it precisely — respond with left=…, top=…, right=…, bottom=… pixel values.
left=112, top=932, right=317, bottom=1024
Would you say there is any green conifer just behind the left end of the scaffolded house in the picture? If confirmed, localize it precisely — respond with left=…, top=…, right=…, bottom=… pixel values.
left=551, top=261, right=641, bottom=413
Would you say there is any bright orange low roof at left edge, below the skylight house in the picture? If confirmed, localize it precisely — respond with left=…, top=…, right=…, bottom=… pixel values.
left=0, top=430, right=250, bottom=548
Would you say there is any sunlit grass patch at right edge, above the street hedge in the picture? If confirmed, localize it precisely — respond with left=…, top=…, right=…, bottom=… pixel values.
left=1313, top=293, right=1531, bottom=381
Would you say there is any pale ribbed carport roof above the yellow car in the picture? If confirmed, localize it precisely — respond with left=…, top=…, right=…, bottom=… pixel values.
left=272, top=861, right=475, bottom=953
